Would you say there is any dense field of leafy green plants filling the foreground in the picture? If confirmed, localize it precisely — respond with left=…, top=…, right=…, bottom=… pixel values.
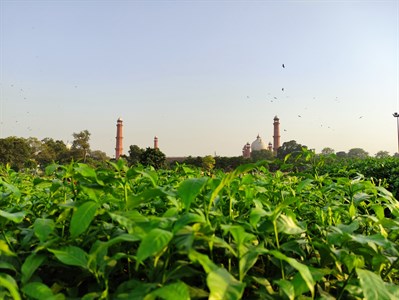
left=0, top=160, right=399, bottom=300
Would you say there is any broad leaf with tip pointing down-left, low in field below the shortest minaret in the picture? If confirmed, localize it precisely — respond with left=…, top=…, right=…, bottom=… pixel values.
left=136, top=228, right=173, bottom=267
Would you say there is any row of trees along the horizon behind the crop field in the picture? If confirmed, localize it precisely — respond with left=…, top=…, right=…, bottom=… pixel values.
left=0, top=130, right=397, bottom=171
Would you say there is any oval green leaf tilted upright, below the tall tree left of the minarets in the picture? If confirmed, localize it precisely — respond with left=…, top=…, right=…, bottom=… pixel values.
left=69, top=201, right=98, bottom=239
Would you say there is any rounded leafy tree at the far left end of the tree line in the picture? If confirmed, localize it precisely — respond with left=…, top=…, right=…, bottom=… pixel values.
left=0, top=136, right=31, bottom=171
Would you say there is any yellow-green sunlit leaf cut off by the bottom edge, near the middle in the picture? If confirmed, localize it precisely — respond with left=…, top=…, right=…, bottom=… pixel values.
left=206, top=268, right=245, bottom=300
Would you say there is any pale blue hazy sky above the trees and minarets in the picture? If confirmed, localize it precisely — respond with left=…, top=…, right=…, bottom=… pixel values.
left=0, top=0, right=399, bottom=157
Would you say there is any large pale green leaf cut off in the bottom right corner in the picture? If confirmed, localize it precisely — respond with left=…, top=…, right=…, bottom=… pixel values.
left=356, top=268, right=395, bottom=300
